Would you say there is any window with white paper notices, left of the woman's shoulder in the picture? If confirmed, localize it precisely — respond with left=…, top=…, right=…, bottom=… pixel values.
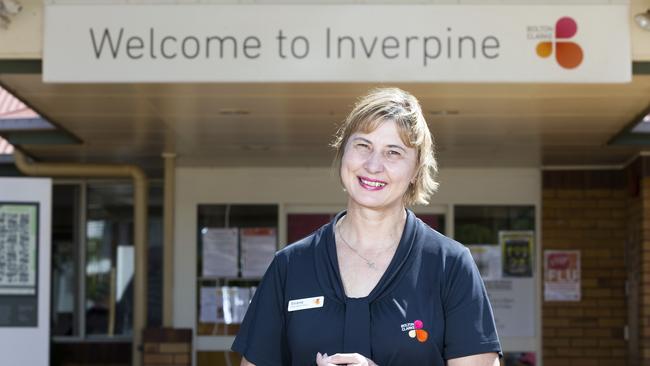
left=197, top=204, right=278, bottom=335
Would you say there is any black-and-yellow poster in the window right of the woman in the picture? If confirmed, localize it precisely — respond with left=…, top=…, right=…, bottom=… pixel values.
left=499, top=231, right=534, bottom=277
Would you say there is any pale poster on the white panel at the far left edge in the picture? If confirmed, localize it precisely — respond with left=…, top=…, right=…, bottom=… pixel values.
left=0, top=202, right=38, bottom=295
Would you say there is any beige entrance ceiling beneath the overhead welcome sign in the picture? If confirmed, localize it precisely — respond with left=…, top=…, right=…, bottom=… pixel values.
left=0, top=74, right=650, bottom=176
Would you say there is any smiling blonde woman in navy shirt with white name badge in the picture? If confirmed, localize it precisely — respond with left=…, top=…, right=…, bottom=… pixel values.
left=232, top=89, right=501, bottom=366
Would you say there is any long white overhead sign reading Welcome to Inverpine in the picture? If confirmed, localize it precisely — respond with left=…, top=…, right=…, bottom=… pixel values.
left=43, top=4, right=631, bottom=83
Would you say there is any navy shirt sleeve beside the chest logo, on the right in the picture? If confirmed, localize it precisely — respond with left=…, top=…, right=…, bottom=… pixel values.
left=443, top=248, right=503, bottom=360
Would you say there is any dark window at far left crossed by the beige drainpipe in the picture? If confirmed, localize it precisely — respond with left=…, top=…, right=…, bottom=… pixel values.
left=51, top=181, right=162, bottom=339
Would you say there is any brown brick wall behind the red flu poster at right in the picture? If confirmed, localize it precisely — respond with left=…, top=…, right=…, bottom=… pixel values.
left=542, top=171, right=628, bottom=366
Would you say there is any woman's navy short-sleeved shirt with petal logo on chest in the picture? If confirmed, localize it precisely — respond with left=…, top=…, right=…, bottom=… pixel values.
left=232, top=210, right=501, bottom=366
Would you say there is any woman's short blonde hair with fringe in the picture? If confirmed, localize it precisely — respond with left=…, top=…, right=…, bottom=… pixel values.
left=331, top=88, right=438, bottom=206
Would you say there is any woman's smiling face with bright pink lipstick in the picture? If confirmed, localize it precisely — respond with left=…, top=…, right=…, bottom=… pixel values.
left=341, top=120, right=417, bottom=209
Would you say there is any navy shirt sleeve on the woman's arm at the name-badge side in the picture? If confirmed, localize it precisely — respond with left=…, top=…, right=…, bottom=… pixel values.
left=232, top=255, right=291, bottom=366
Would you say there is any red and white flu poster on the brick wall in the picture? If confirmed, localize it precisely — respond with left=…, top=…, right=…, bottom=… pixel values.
left=544, top=250, right=581, bottom=301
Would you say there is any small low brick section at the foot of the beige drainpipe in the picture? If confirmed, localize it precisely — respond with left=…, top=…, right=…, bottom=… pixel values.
left=142, top=328, right=192, bottom=366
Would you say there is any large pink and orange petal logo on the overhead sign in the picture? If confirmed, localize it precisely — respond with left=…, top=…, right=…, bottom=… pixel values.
left=536, top=17, right=583, bottom=69
